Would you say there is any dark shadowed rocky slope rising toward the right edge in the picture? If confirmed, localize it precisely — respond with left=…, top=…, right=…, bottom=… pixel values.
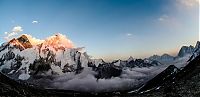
left=131, top=42, right=200, bottom=97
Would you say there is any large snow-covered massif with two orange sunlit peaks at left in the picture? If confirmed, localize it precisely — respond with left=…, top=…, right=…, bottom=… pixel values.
left=0, top=34, right=94, bottom=80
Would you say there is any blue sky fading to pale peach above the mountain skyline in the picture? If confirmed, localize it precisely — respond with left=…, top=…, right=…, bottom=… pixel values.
left=0, top=0, right=199, bottom=60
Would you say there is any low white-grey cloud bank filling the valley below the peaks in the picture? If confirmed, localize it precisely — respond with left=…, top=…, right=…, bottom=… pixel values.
left=30, top=67, right=166, bottom=92
